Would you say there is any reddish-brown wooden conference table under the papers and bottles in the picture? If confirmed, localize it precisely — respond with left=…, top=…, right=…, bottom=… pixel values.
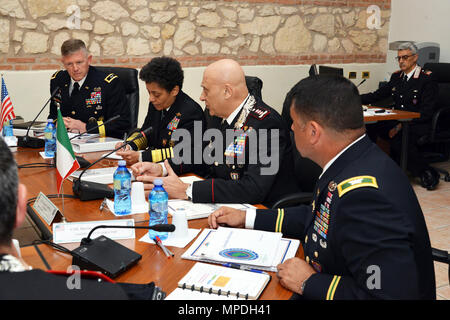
left=15, top=148, right=303, bottom=300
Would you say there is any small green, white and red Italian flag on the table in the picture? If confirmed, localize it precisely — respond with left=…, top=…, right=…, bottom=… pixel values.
left=56, top=108, right=80, bottom=193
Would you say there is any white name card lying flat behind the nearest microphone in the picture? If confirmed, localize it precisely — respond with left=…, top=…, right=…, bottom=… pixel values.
left=53, top=219, right=136, bottom=243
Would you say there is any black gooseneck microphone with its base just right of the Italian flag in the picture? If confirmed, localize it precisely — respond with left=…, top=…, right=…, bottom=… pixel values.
left=72, top=127, right=153, bottom=201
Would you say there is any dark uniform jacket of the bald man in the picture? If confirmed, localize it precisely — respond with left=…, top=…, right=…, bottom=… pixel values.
left=192, top=95, right=299, bottom=206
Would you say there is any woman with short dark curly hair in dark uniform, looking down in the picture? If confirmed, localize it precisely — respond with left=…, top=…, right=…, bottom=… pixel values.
left=117, top=57, right=204, bottom=174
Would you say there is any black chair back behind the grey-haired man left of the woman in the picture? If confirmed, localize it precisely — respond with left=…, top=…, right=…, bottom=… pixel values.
left=96, top=67, right=139, bottom=128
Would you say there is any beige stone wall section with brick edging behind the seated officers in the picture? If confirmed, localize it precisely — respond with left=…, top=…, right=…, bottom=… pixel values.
left=0, top=0, right=390, bottom=70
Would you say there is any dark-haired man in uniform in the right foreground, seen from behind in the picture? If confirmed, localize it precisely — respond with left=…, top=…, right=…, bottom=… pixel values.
left=208, top=76, right=436, bottom=300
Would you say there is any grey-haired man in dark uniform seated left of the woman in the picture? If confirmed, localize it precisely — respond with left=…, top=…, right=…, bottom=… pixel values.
left=48, top=39, right=131, bottom=138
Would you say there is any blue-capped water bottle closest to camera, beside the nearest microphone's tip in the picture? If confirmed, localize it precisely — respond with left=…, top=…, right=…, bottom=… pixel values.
left=148, top=179, right=169, bottom=240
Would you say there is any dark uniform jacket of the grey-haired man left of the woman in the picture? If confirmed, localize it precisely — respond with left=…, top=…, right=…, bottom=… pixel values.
left=48, top=66, right=131, bottom=138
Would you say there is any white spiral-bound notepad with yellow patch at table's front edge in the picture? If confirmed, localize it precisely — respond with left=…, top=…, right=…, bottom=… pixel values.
left=166, top=262, right=270, bottom=300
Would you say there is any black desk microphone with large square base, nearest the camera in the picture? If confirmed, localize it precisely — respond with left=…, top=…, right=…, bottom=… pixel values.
left=70, top=224, right=175, bottom=278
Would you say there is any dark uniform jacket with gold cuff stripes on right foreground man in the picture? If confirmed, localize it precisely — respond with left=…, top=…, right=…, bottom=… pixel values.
left=254, top=136, right=436, bottom=299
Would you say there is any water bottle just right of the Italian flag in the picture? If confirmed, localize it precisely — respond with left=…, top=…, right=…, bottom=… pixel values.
left=114, top=160, right=131, bottom=215
